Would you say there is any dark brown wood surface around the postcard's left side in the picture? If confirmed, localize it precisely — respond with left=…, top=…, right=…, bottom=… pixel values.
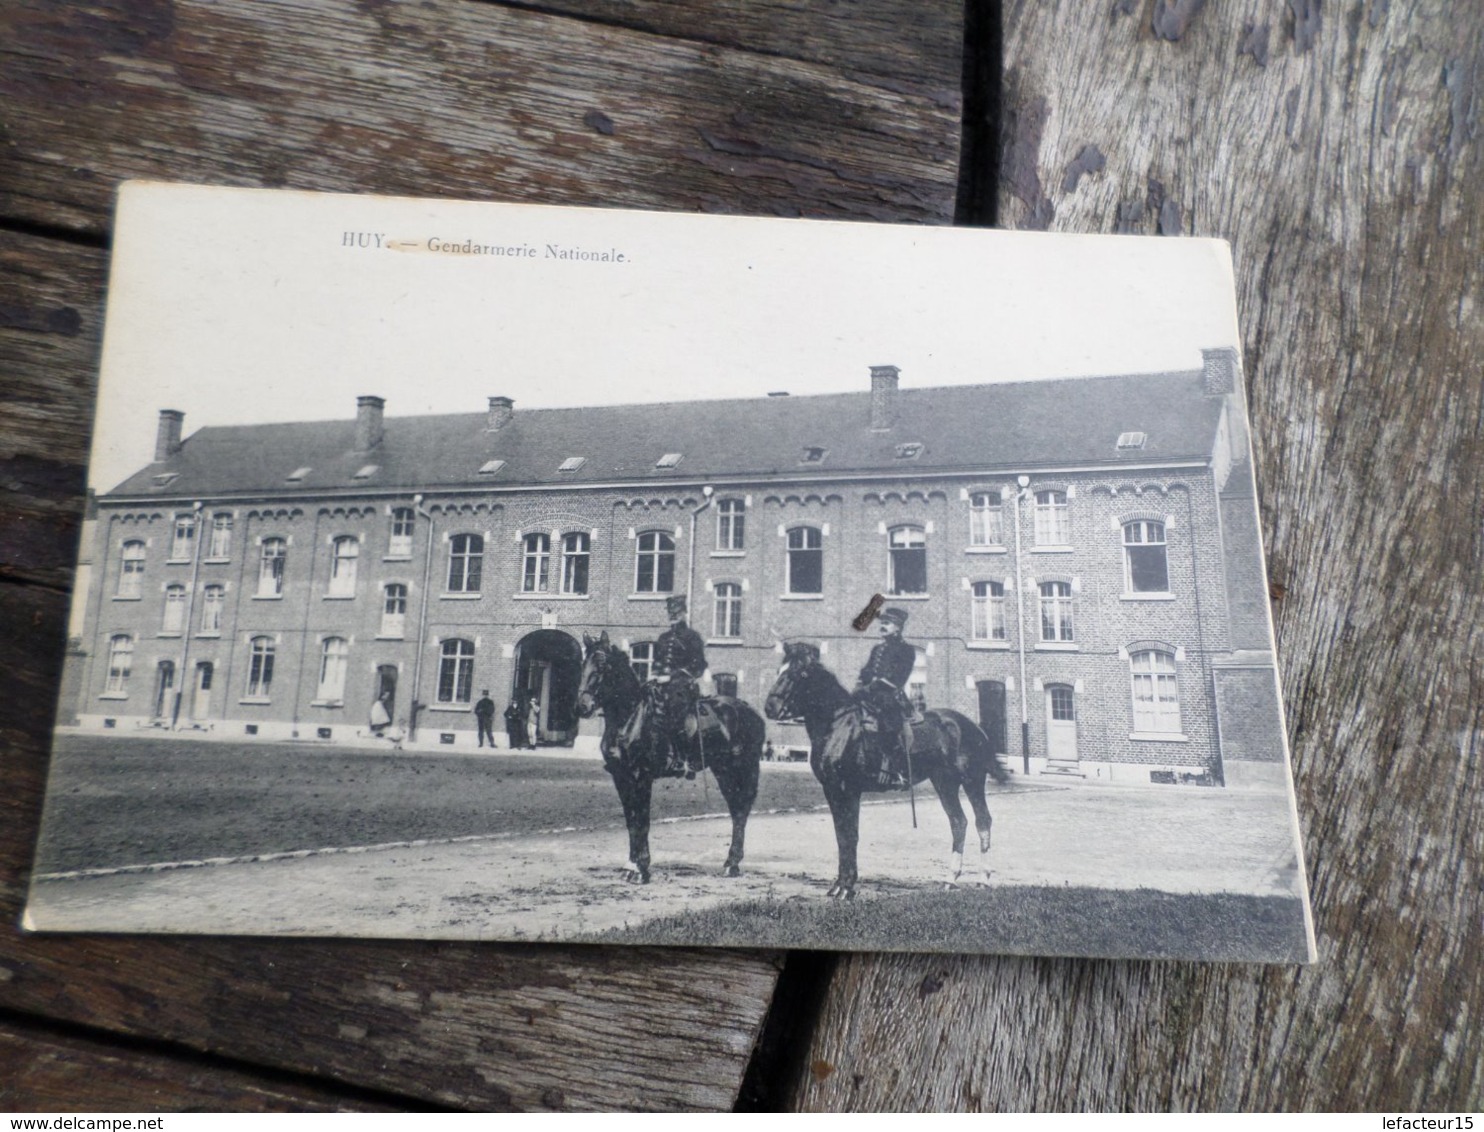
left=0, top=0, right=962, bottom=1108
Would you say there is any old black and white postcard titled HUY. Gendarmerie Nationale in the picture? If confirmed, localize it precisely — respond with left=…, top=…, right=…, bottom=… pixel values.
left=27, top=182, right=1313, bottom=963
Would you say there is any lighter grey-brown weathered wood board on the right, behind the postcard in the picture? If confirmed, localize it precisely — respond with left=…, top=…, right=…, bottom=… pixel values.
left=794, top=0, right=1484, bottom=1111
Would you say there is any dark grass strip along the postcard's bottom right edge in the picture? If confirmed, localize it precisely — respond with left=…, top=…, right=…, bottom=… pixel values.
left=586, top=886, right=1306, bottom=963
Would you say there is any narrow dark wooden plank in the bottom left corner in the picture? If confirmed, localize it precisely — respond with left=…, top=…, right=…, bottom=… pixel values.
left=0, top=1021, right=396, bottom=1113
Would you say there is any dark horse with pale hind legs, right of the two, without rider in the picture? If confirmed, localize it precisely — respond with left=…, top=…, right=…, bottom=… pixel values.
left=764, top=642, right=1011, bottom=899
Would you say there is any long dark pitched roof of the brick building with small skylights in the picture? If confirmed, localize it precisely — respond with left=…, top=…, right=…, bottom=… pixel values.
left=108, top=371, right=1221, bottom=497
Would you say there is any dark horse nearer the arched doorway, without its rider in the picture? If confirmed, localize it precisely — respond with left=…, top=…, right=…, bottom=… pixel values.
left=577, top=632, right=767, bottom=884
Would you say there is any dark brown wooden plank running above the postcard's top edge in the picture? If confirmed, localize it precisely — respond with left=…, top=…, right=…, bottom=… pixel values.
left=0, top=0, right=960, bottom=233
